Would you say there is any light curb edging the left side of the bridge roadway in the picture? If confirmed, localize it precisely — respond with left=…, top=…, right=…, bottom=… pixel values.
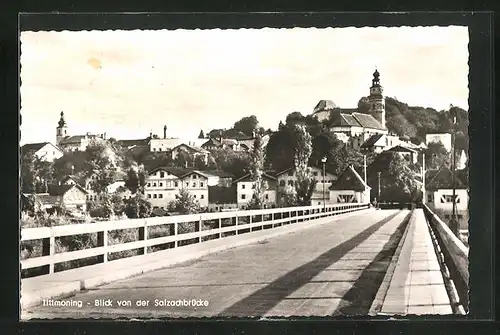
left=20, top=209, right=370, bottom=319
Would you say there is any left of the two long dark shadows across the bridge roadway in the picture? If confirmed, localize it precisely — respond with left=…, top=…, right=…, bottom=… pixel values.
left=218, top=211, right=399, bottom=317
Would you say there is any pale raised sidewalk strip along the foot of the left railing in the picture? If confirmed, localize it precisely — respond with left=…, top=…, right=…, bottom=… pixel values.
left=21, top=209, right=374, bottom=309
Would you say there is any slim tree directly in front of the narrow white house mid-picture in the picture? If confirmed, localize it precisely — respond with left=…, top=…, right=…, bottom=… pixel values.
left=248, top=136, right=267, bottom=209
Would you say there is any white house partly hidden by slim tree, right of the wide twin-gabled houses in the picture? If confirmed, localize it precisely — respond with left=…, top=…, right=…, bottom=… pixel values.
left=234, top=173, right=277, bottom=208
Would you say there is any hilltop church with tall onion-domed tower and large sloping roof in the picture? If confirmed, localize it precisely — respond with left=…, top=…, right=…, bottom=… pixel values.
left=313, top=70, right=388, bottom=148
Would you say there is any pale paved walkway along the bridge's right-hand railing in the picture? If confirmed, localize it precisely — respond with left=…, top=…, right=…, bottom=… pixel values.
left=378, top=209, right=452, bottom=315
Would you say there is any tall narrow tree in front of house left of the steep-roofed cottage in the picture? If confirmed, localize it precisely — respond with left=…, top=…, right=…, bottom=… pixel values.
left=295, top=125, right=317, bottom=206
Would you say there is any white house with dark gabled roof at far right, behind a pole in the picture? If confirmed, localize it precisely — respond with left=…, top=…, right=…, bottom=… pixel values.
left=424, top=165, right=469, bottom=236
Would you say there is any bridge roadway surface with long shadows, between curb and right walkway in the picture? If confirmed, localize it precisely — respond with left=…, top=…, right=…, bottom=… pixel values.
left=23, top=209, right=410, bottom=319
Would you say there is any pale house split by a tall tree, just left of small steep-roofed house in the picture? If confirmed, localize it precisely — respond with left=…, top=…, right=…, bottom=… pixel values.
left=276, top=167, right=337, bottom=205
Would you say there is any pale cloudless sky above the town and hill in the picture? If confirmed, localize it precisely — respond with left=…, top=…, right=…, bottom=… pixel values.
left=20, top=26, right=469, bottom=144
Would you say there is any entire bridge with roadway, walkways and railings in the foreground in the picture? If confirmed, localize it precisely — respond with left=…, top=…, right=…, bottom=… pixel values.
left=21, top=204, right=468, bottom=320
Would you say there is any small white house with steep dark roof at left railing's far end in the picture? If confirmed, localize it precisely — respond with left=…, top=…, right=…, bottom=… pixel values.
left=330, top=166, right=371, bottom=203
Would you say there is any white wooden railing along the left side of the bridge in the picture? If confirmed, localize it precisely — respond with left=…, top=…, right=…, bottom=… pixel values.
left=21, top=203, right=369, bottom=273
